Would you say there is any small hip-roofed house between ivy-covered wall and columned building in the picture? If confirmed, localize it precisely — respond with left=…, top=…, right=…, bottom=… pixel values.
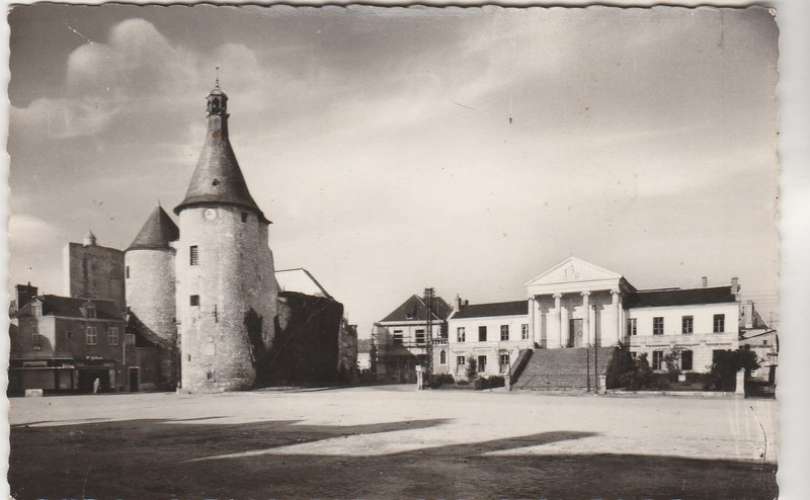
left=371, top=295, right=452, bottom=382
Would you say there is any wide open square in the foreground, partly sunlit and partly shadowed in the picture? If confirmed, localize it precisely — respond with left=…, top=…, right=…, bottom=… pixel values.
left=9, top=386, right=778, bottom=499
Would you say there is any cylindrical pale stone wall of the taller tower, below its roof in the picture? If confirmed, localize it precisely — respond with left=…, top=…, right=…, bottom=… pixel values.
left=174, top=206, right=278, bottom=392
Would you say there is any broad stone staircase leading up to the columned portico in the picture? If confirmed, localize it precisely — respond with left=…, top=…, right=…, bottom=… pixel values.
left=512, top=347, right=616, bottom=391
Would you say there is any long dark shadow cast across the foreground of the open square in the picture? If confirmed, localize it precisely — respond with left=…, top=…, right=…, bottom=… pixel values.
left=9, top=419, right=777, bottom=500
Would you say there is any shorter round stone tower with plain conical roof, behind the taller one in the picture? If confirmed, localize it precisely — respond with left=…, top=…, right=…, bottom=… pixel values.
left=124, top=206, right=180, bottom=344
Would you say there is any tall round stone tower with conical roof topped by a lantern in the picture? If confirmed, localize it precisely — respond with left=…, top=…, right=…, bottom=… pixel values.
left=174, top=85, right=278, bottom=392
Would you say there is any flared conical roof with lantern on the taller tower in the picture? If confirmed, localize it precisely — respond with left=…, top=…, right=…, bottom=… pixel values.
left=174, top=87, right=269, bottom=222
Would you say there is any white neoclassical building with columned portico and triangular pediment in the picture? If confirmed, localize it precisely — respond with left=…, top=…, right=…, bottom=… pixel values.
left=448, top=257, right=753, bottom=376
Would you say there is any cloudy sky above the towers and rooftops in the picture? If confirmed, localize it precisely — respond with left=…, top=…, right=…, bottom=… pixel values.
left=8, top=5, right=778, bottom=336
